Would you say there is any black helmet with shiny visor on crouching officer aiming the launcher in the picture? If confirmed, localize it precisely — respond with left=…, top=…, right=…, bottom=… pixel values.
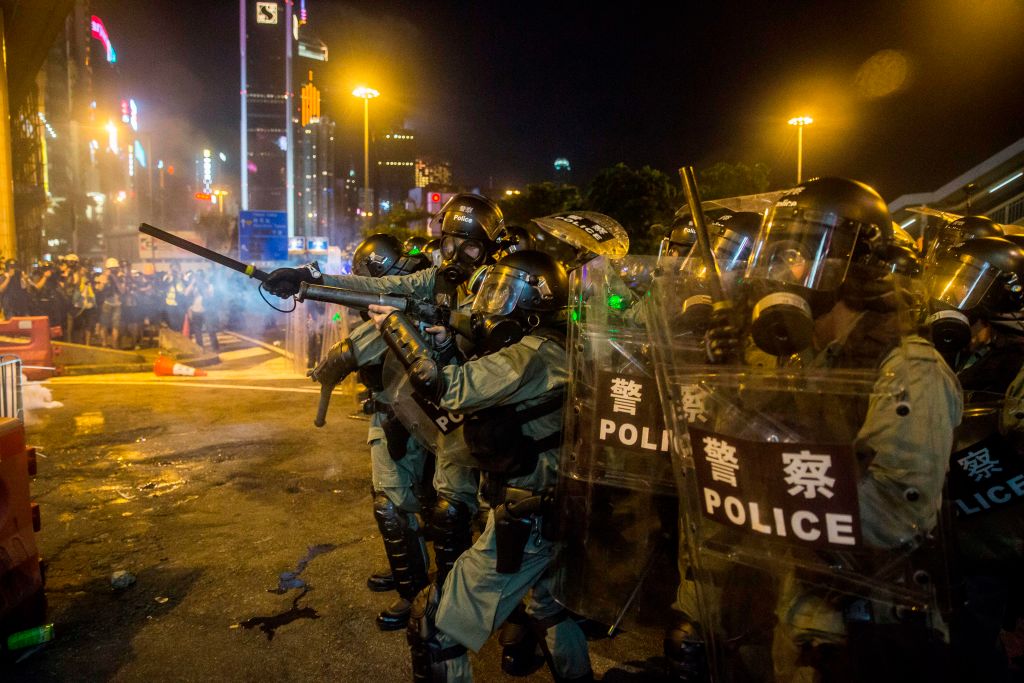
left=472, top=251, right=569, bottom=352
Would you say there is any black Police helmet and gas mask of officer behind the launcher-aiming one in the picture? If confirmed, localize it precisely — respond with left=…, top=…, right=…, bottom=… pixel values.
left=436, top=194, right=505, bottom=285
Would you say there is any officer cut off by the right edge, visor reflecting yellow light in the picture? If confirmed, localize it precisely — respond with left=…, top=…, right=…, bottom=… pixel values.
left=927, top=237, right=1024, bottom=681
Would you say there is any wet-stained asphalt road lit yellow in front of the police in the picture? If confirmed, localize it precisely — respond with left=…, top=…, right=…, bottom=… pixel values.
left=0, top=339, right=660, bottom=681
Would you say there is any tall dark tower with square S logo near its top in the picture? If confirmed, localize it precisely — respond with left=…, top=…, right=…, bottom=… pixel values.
left=239, top=0, right=290, bottom=234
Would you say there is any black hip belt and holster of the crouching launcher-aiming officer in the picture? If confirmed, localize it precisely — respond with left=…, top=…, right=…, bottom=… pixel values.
left=484, top=478, right=555, bottom=573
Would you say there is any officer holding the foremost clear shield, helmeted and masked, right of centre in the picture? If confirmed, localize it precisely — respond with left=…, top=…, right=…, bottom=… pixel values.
left=684, top=178, right=962, bottom=680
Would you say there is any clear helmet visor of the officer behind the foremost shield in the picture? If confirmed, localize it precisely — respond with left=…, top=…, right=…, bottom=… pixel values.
left=746, top=207, right=861, bottom=292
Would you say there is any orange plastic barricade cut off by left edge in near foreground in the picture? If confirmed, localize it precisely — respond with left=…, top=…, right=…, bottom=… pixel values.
left=0, top=419, right=46, bottom=638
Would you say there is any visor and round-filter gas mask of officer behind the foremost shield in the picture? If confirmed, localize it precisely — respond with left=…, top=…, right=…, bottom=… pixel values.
left=746, top=210, right=860, bottom=356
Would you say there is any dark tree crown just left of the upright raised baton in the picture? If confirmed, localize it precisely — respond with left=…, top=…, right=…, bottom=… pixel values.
left=584, top=164, right=679, bottom=254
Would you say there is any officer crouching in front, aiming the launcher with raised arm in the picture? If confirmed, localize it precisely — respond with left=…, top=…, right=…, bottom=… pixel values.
left=375, top=251, right=592, bottom=681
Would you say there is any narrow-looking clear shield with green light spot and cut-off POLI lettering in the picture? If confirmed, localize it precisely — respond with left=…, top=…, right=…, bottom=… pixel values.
left=556, top=256, right=679, bottom=626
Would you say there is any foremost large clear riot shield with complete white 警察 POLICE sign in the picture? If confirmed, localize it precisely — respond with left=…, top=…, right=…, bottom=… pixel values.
left=649, top=264, right=961, bottom=681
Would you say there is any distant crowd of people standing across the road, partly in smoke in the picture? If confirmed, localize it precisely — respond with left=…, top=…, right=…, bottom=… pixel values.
left=0, top=254, right=225, bottom=352
